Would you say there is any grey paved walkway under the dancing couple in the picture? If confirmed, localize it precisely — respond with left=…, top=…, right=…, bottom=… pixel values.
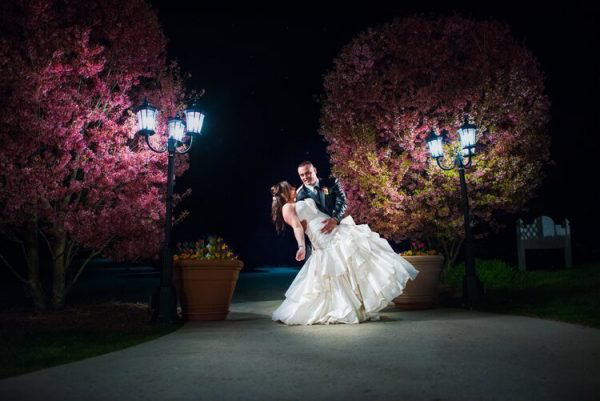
left=0, top=272, right=600, bottom=401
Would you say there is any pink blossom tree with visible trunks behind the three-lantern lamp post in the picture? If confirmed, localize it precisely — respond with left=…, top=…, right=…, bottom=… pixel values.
left=0, top=0, right=188, bottom=309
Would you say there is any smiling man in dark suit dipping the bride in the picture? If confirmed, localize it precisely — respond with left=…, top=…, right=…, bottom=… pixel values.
left=296, top=161, right=348, bottom=233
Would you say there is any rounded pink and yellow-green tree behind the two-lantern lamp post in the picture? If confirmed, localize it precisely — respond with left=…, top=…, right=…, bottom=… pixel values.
left=321, top=16, right=549, bottom=265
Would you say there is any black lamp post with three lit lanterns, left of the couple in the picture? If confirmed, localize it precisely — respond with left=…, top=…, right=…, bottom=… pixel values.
left=136, top=100, right=204, bottom=325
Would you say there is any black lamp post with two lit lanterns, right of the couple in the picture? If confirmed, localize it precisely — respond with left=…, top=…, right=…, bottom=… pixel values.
left=427, top=118, right=484, bottom=307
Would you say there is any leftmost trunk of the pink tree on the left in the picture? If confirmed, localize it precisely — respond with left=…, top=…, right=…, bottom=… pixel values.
left=24, top=212, right=46, bottom=310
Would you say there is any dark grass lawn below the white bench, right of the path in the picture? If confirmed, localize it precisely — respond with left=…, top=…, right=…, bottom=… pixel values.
left=442, top=260, right=600, bottom=328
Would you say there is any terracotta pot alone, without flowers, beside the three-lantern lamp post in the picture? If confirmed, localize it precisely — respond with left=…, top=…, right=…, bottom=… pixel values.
left=174, top=260, right=244, bottom=321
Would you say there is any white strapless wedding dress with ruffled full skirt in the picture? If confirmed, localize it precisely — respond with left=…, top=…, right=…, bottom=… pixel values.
left=272, top=198, right=419, bottom=325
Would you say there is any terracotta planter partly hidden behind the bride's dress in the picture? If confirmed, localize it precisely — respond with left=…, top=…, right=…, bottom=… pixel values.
left=394, top=255, right=444, bottom=310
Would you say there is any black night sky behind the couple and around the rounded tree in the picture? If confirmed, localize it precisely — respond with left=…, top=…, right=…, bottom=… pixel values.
left=151, top=0, right=600, bottom=267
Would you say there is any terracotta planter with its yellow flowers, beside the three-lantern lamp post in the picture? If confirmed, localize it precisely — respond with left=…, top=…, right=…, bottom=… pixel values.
left=173, top=236, right=244, bottom=320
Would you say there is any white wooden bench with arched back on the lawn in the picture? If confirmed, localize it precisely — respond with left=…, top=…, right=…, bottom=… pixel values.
left=517, top=216, right=573, bottom=271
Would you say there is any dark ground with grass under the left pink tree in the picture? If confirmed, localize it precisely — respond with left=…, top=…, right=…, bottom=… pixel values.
left=0, top=302, right=177, bottom=378
